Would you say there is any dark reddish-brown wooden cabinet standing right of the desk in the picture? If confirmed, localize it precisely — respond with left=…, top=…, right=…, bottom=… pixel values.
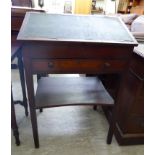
left=102, top=52, right=144, bottom=145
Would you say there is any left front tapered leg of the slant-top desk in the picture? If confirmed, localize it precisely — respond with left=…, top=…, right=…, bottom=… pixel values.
left=24, top=57, right=39, bottom=148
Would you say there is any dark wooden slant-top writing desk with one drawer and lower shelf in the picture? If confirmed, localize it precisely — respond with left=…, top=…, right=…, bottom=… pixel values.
left=17, top=12, right=137, bottom=147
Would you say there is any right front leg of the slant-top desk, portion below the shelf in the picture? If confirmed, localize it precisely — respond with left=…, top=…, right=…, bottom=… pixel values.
left=107, top=108, right=116, bottom=144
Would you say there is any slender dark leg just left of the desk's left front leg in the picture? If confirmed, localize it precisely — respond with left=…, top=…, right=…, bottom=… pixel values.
left=18, top=52, right=28, bottom=116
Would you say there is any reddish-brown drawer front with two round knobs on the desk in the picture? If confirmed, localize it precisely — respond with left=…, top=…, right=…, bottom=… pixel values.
left=32, top=59, right=126, bottom=73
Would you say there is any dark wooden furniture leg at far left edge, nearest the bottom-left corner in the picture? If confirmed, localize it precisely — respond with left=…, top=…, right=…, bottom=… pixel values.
left=11, top=88, right=20, bottom=146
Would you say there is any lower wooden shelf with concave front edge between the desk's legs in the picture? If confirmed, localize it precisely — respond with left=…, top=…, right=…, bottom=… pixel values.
left=35, top=77, right=114, bottom=108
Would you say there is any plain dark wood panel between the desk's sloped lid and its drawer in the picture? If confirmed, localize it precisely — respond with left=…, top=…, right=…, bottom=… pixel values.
left=25, top=40, right=133, bottom=60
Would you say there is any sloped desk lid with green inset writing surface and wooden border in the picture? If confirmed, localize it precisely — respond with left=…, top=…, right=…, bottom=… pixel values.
left=17, top=12, right=137, bottom=45
